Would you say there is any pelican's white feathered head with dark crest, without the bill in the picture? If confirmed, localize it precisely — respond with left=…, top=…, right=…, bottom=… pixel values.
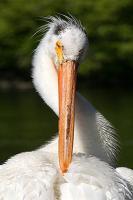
left=45, top=17, right=88, bottom=68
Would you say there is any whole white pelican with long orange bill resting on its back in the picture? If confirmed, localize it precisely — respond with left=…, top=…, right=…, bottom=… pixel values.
left=0, top=16, right=133, bottom=200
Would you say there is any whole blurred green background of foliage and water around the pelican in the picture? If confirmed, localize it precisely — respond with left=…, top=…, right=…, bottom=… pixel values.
left=0, top=0, right=133, bottom=167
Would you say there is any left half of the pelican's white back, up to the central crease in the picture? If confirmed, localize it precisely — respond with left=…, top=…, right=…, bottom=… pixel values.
left=0, top=151, right=57, bottom=200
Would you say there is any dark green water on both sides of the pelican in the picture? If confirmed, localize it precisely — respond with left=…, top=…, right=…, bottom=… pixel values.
left=0, top=84, right=133, bottom=168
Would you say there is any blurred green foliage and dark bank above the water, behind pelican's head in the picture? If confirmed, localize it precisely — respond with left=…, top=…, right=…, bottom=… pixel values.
left=0, top=0, right=133, bottom=79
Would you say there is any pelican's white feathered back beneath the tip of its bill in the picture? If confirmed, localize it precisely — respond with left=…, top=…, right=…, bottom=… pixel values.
left=0, top=152, right=131, bottom=200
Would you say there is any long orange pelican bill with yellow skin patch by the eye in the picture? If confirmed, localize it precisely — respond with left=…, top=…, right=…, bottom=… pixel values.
left=56, top=43, right=78, bottom=174
